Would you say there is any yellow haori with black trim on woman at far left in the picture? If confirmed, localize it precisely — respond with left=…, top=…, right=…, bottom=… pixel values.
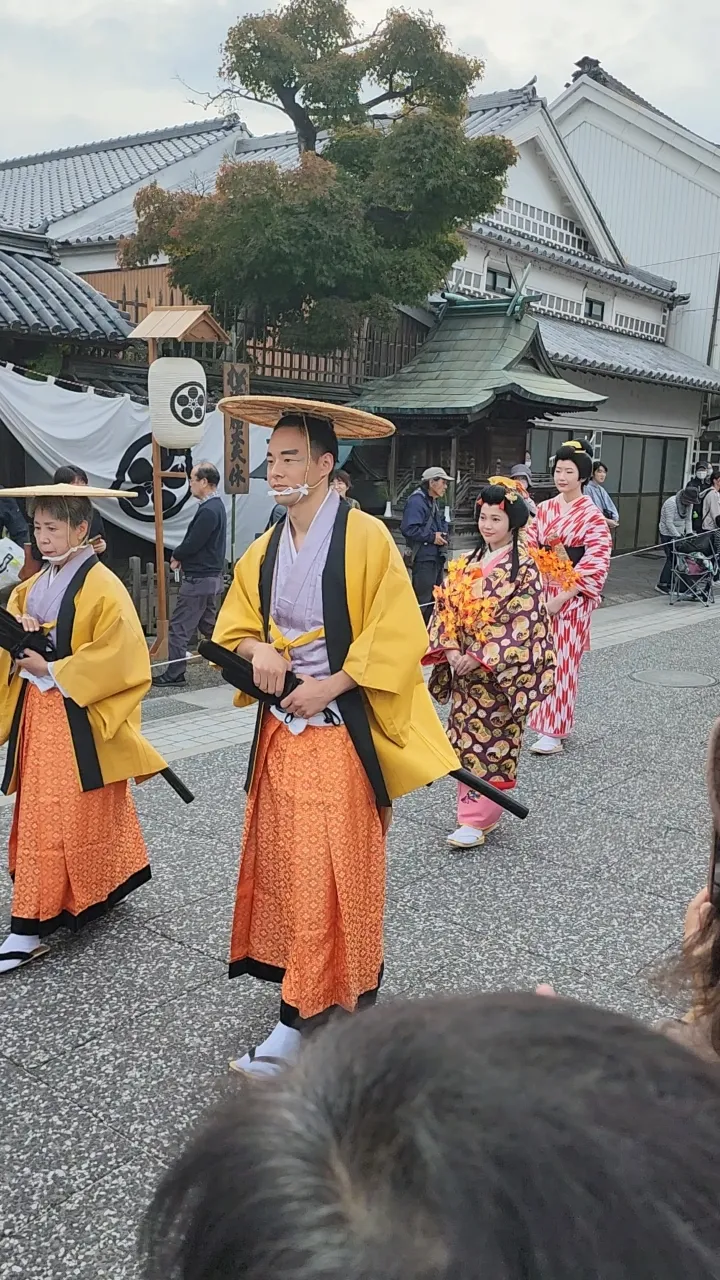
left=0, top=558, right=167, bottom=795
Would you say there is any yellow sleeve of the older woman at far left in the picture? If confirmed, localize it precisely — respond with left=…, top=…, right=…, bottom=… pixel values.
left=53, top=584, right=151, bottom=741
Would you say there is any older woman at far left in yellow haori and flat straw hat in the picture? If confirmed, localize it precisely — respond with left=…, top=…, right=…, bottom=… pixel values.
left=0, top=485, right=167, bottom=974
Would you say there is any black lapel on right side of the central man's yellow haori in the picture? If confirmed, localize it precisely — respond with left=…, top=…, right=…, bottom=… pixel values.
left=323, top=502, right=389, bottom=809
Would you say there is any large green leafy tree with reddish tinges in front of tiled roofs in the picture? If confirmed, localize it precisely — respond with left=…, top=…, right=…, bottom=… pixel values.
left=120, top=0, right=515, bottom=352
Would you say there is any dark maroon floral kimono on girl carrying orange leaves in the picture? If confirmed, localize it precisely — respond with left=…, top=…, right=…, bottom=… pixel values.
left=424, top=541, right=555, bottom=831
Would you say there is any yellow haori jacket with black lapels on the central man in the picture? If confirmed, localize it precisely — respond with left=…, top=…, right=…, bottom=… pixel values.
left=213, top=504, right=459, bottom=805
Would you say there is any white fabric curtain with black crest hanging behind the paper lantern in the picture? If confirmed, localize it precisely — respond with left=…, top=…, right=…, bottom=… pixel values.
left=0, top=365, right=273, bottom=558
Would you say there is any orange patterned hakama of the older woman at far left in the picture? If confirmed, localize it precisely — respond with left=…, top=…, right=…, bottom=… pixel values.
left=9, top=685, right=150, bottom=937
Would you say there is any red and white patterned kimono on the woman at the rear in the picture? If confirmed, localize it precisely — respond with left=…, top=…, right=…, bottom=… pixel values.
left=527, top=494, right=612, bottom=737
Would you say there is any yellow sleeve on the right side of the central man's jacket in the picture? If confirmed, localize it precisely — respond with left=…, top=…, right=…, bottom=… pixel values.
left=343, top=512, right=428, bottom=746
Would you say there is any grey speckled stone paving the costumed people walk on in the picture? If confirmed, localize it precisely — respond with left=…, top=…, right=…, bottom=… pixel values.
left=0, top=598, right=720, bottom=1280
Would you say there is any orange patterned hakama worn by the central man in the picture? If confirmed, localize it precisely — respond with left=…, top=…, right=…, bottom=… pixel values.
left=229, top=714, right=386, bottom=1021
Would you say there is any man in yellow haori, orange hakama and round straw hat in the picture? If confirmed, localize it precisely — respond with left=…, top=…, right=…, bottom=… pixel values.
left=214, top=397, right=457, bottom=1074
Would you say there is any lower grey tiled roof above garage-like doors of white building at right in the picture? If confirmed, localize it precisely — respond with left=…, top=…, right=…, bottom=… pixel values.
left=539, top=316, right=720, bottom=392
